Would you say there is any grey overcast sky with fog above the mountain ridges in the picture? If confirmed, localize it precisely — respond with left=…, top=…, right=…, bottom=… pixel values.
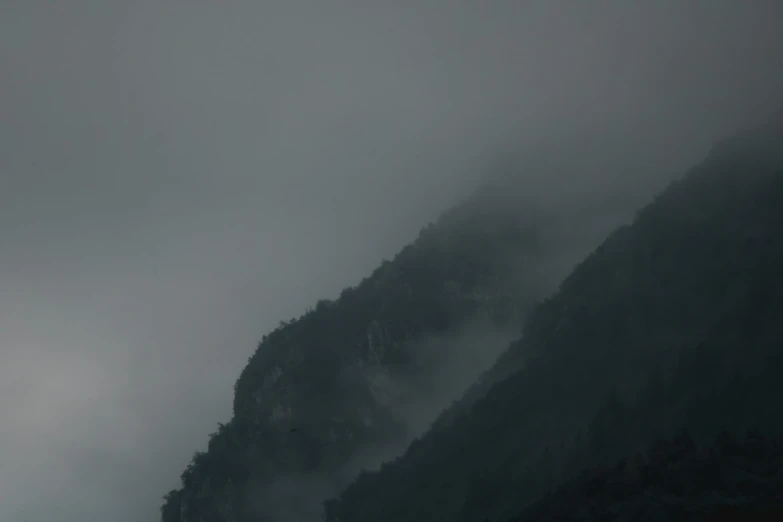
left=0, top=0, right=783, bottom=522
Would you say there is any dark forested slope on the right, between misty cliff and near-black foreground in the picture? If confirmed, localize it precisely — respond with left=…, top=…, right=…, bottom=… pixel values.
left=326, top=111, right=783, bottom=522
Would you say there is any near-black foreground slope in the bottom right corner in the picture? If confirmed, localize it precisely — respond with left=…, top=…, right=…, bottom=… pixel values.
left=513, top=431, right=783, bottom=522
